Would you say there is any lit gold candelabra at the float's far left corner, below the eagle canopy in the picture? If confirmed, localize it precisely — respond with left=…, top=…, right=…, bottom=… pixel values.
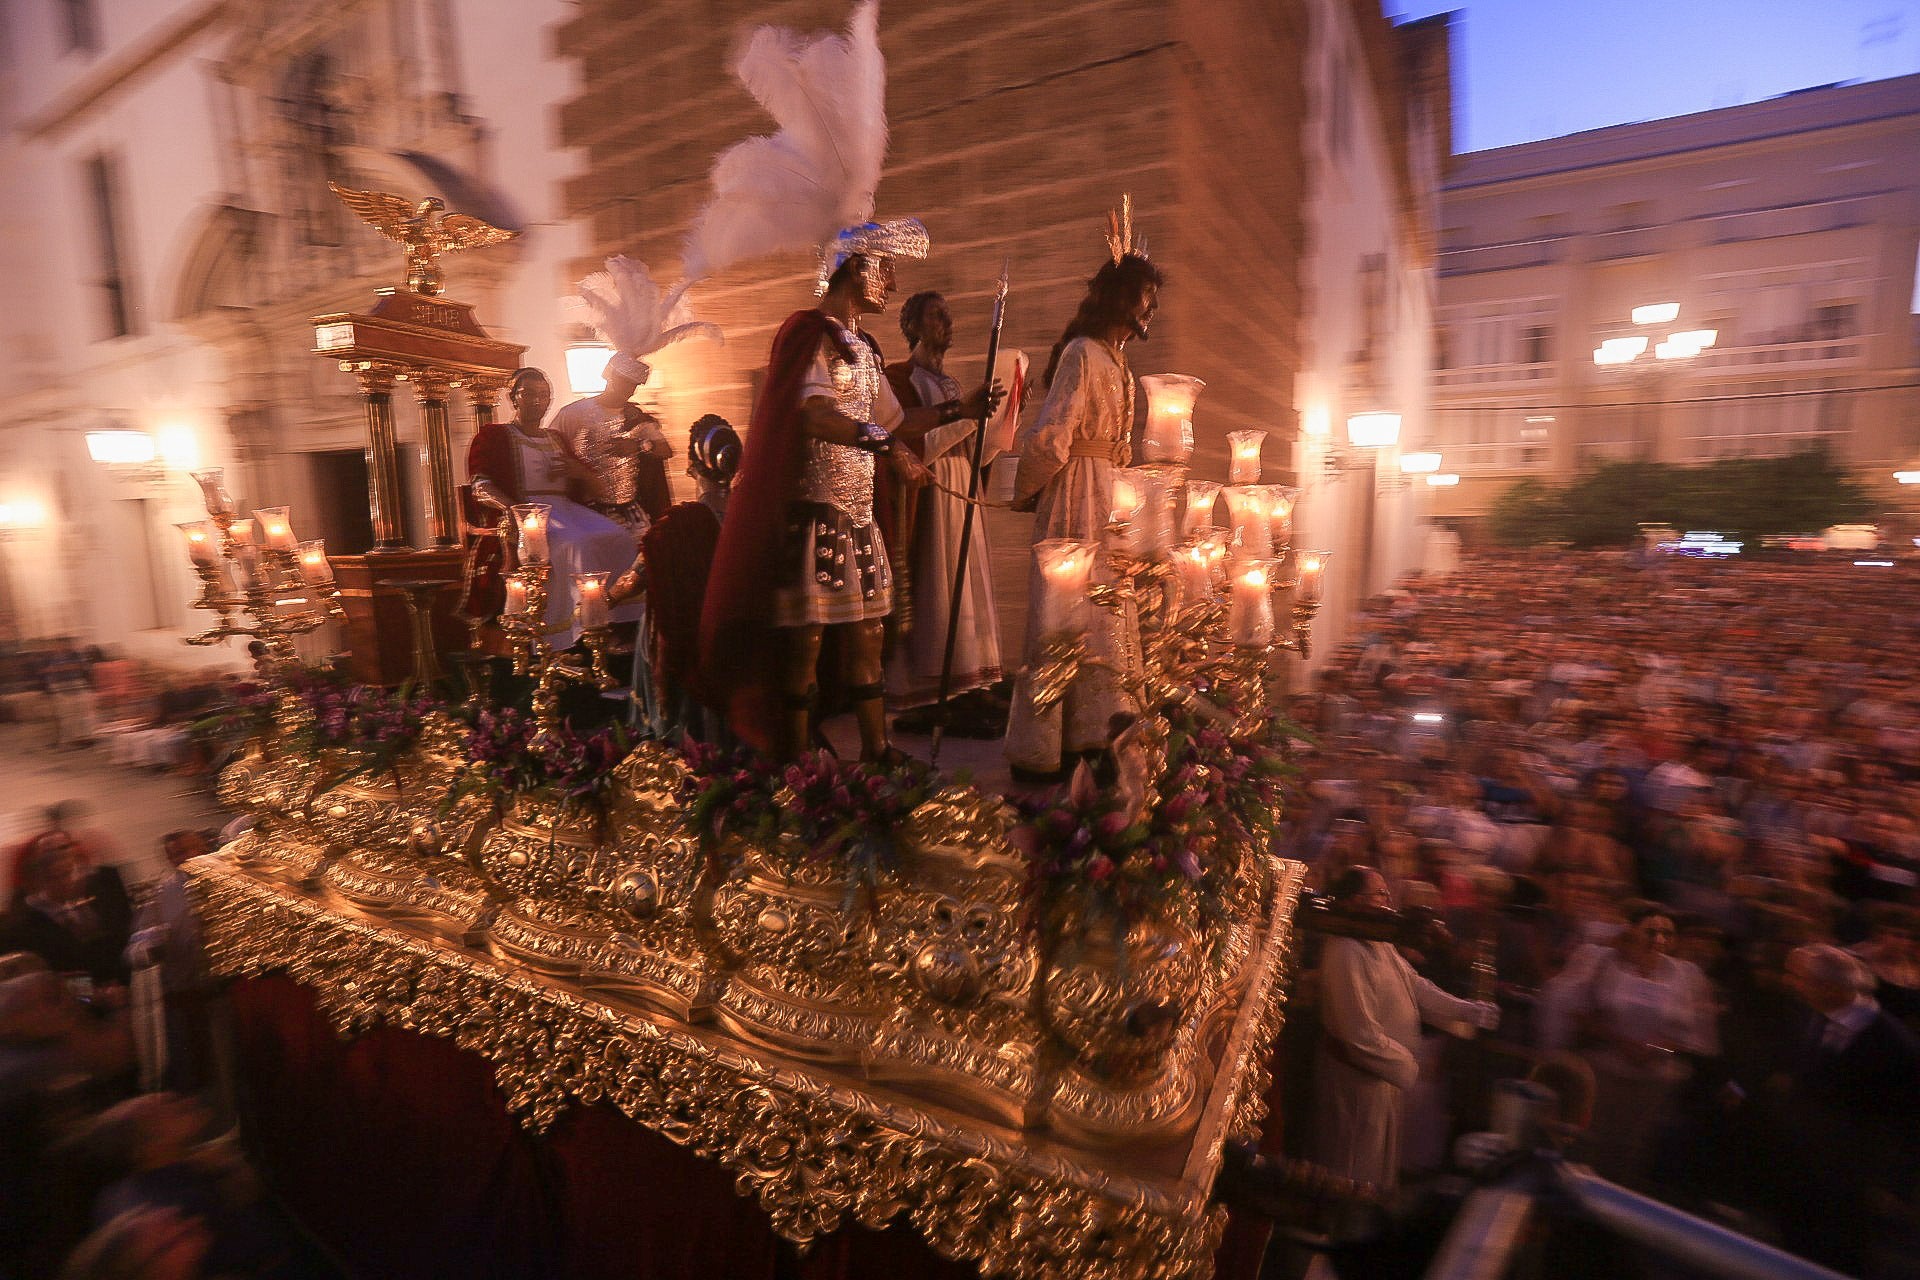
left=179, top=468, right=346, bottom=672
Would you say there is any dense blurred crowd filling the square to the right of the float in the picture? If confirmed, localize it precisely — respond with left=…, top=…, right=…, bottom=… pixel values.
left=1292, top=551, right=1920, bottom=1274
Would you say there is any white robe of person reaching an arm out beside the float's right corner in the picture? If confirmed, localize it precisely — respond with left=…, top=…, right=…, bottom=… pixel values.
left=1313, top=938, right=1478, bottom=1190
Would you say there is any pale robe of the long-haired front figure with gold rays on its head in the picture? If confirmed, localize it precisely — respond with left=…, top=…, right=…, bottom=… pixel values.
left=1006, top=338, right=1140, bottom=771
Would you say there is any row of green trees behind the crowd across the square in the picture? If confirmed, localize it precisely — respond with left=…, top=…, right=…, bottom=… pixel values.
left=1488, top=449, right=1874, bottom=547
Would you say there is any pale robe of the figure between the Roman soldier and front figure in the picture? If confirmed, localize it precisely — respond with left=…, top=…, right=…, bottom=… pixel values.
left=887, top=365, right=1000, bottom=706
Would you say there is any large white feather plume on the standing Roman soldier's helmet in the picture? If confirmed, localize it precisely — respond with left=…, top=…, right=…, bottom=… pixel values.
left=682, top=0, right=887, bottom=282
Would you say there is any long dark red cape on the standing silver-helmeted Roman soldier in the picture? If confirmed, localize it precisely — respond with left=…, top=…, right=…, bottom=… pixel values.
left=695, top=307, right=852, bottom=750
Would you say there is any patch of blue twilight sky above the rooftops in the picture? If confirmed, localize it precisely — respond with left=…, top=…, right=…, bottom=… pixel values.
left=1384, top=0, right=1920, bottom=152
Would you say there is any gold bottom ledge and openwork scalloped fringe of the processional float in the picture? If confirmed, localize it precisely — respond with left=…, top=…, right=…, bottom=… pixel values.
left=188, top=858, right=1300, bottom=1280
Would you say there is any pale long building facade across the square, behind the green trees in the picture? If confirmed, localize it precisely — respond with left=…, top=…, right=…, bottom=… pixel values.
left=1415, top=75, right=1920, bottom=520
